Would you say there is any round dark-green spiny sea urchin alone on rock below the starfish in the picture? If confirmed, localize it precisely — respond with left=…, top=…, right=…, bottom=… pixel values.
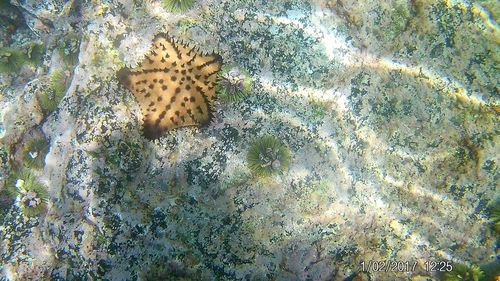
left=247, top=136, right=290, bottom=177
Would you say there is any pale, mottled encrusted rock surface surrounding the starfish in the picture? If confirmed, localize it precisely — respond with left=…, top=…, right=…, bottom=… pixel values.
left=0, top=0, right=500, bottom=280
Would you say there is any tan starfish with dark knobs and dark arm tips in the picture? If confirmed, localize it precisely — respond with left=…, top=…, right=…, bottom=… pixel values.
left=118, top=34, right=222, bottom=140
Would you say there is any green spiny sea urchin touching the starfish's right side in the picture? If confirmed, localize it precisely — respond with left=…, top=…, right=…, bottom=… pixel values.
left=216, top=65, right=252, bottom=101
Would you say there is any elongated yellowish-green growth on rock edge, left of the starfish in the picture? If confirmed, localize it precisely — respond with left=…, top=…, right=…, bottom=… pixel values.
left=37, top=68, right=66, bottom=115
